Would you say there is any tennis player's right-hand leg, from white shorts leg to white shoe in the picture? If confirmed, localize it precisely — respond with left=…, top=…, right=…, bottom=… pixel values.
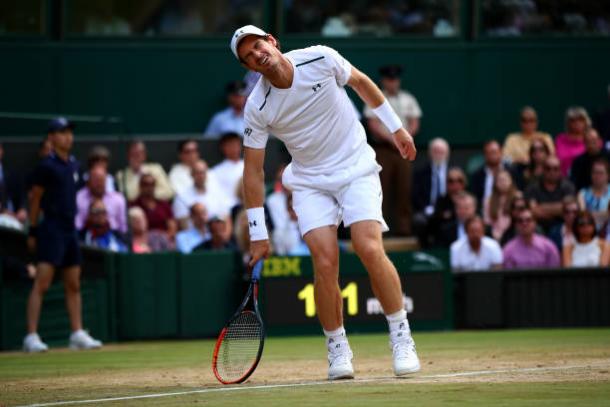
left=342, top=174, right=419, bottom=375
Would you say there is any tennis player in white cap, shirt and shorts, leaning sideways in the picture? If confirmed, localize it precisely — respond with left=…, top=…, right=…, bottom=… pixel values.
left=231, top=25, right=420, bottom=380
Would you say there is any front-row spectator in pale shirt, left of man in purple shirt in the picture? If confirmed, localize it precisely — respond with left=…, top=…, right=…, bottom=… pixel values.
left=451, top=216, right=503, bottom=271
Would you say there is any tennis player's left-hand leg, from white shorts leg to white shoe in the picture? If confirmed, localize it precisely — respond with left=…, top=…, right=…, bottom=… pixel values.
left=292, top=190, right=354, bottom=380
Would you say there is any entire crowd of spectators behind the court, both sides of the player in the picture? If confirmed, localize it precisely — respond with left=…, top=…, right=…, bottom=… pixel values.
left=0, top=75, right=610, bottom=276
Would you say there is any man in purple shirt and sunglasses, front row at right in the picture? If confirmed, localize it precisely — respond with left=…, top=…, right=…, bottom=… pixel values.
left=504, top=209, right=560, bottom=269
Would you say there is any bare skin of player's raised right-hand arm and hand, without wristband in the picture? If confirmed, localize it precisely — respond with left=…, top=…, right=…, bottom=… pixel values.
left=347, top=67, right=417, bottom=161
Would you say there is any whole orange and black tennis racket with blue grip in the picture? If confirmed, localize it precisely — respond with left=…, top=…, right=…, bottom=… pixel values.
left=212, top=260, right=265, bottom=384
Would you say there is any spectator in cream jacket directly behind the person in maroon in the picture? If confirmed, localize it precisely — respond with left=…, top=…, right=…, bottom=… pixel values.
left=116, top=140, right=174, bottom=201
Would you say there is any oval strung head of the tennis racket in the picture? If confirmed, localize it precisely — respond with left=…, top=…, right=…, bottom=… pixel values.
left=217, top=311, right=263, bottom=381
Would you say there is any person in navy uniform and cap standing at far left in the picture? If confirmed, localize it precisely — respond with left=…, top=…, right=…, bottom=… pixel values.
left=23, top=117, right=102, bottom=352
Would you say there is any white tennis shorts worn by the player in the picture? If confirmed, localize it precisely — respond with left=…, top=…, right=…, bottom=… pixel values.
left=292, top=171, right=389, bottom=236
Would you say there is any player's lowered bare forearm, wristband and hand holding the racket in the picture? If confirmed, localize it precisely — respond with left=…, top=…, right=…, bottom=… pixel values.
left=243, top=147, right=271, bottom=266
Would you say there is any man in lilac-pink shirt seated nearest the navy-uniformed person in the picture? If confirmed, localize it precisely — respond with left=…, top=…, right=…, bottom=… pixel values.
left=75, top=165, right=127, bottom=233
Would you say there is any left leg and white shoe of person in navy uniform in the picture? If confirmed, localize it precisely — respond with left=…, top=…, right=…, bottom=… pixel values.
left=23, top=262, right=55, bottom=352
